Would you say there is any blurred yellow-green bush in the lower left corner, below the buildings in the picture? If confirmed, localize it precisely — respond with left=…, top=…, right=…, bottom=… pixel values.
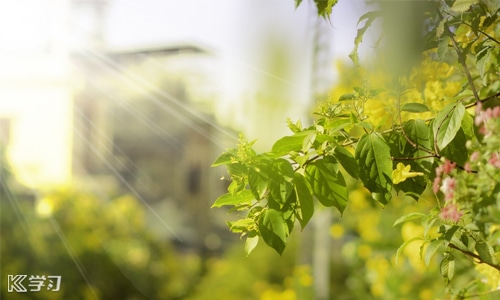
left=0, top=182, right=201, bottom=299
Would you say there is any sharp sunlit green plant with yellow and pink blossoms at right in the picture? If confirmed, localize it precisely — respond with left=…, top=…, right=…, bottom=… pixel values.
left=213, top=0, right=500, bottom=297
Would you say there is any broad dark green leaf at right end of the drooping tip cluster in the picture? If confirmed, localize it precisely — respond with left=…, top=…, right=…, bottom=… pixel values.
left=306, top=156, right=348, bottom=214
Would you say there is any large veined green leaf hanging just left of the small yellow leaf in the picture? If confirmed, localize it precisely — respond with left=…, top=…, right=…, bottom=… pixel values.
left=355, top=132, right=392, bottom=205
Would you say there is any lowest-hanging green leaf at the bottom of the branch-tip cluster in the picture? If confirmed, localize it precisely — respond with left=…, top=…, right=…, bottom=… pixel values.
left=258, top=209, right=287, bottom=255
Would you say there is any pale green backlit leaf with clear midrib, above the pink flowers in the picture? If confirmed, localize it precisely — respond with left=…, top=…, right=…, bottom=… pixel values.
left=432, top=102, right=465, bottom=149
